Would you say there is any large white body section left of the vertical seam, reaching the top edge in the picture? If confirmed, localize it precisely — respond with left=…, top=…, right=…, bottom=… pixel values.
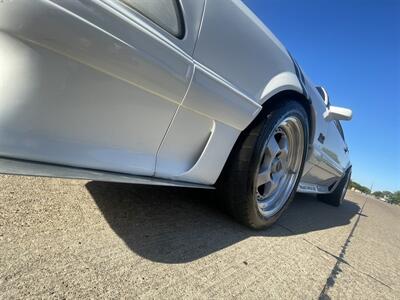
left=0, top=0, right=202, bottom=175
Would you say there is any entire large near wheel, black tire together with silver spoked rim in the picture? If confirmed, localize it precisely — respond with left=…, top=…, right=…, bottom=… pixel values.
left=217, top=100, right=309, bottom=229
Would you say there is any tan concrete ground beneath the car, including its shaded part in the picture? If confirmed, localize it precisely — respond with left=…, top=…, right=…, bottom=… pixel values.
left=0, top=176, right=400, bottom=299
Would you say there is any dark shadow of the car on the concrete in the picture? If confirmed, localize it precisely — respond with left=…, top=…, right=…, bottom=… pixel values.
left=86, top=181, right=359, bottom=263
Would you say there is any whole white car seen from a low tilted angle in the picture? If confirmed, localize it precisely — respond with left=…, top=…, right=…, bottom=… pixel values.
left=0, top=0, right=352, bottom=228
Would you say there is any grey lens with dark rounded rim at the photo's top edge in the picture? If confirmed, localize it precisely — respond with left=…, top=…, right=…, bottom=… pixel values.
left=120, top=0, right=184, bottom=38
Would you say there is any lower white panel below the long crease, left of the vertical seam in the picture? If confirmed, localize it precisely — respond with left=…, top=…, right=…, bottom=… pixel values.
left=0, top=35, right=177, bottom=175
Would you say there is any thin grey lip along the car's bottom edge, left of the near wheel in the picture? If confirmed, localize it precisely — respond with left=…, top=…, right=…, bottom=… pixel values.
left=0, top=157, right=215, bottom=189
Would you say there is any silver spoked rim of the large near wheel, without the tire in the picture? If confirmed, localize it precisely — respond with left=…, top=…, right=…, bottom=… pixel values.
left=255, top=116, right=304, bottom=218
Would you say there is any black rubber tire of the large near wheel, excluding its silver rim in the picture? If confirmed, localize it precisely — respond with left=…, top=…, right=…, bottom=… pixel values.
left=217, top=100, right=309, bottom=229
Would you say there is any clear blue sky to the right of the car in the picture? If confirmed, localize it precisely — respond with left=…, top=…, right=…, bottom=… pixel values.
left=243, top=0, right=400, bottom=191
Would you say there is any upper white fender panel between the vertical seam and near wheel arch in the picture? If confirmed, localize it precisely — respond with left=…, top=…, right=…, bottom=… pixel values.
left=194, top=0, right=295, bottom=103
